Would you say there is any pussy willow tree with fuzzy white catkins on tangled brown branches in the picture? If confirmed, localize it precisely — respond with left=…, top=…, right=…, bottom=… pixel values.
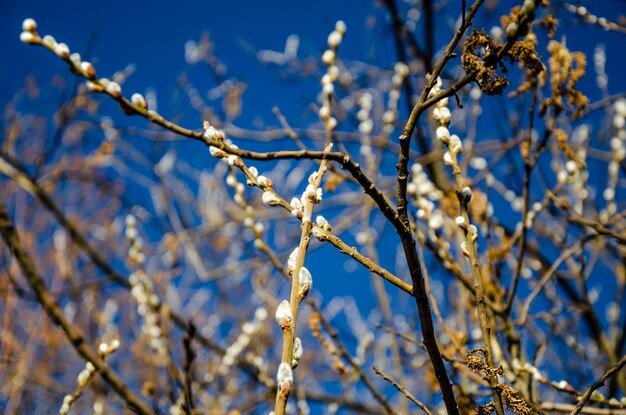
left=0, top=0, right=626, bottom=414
